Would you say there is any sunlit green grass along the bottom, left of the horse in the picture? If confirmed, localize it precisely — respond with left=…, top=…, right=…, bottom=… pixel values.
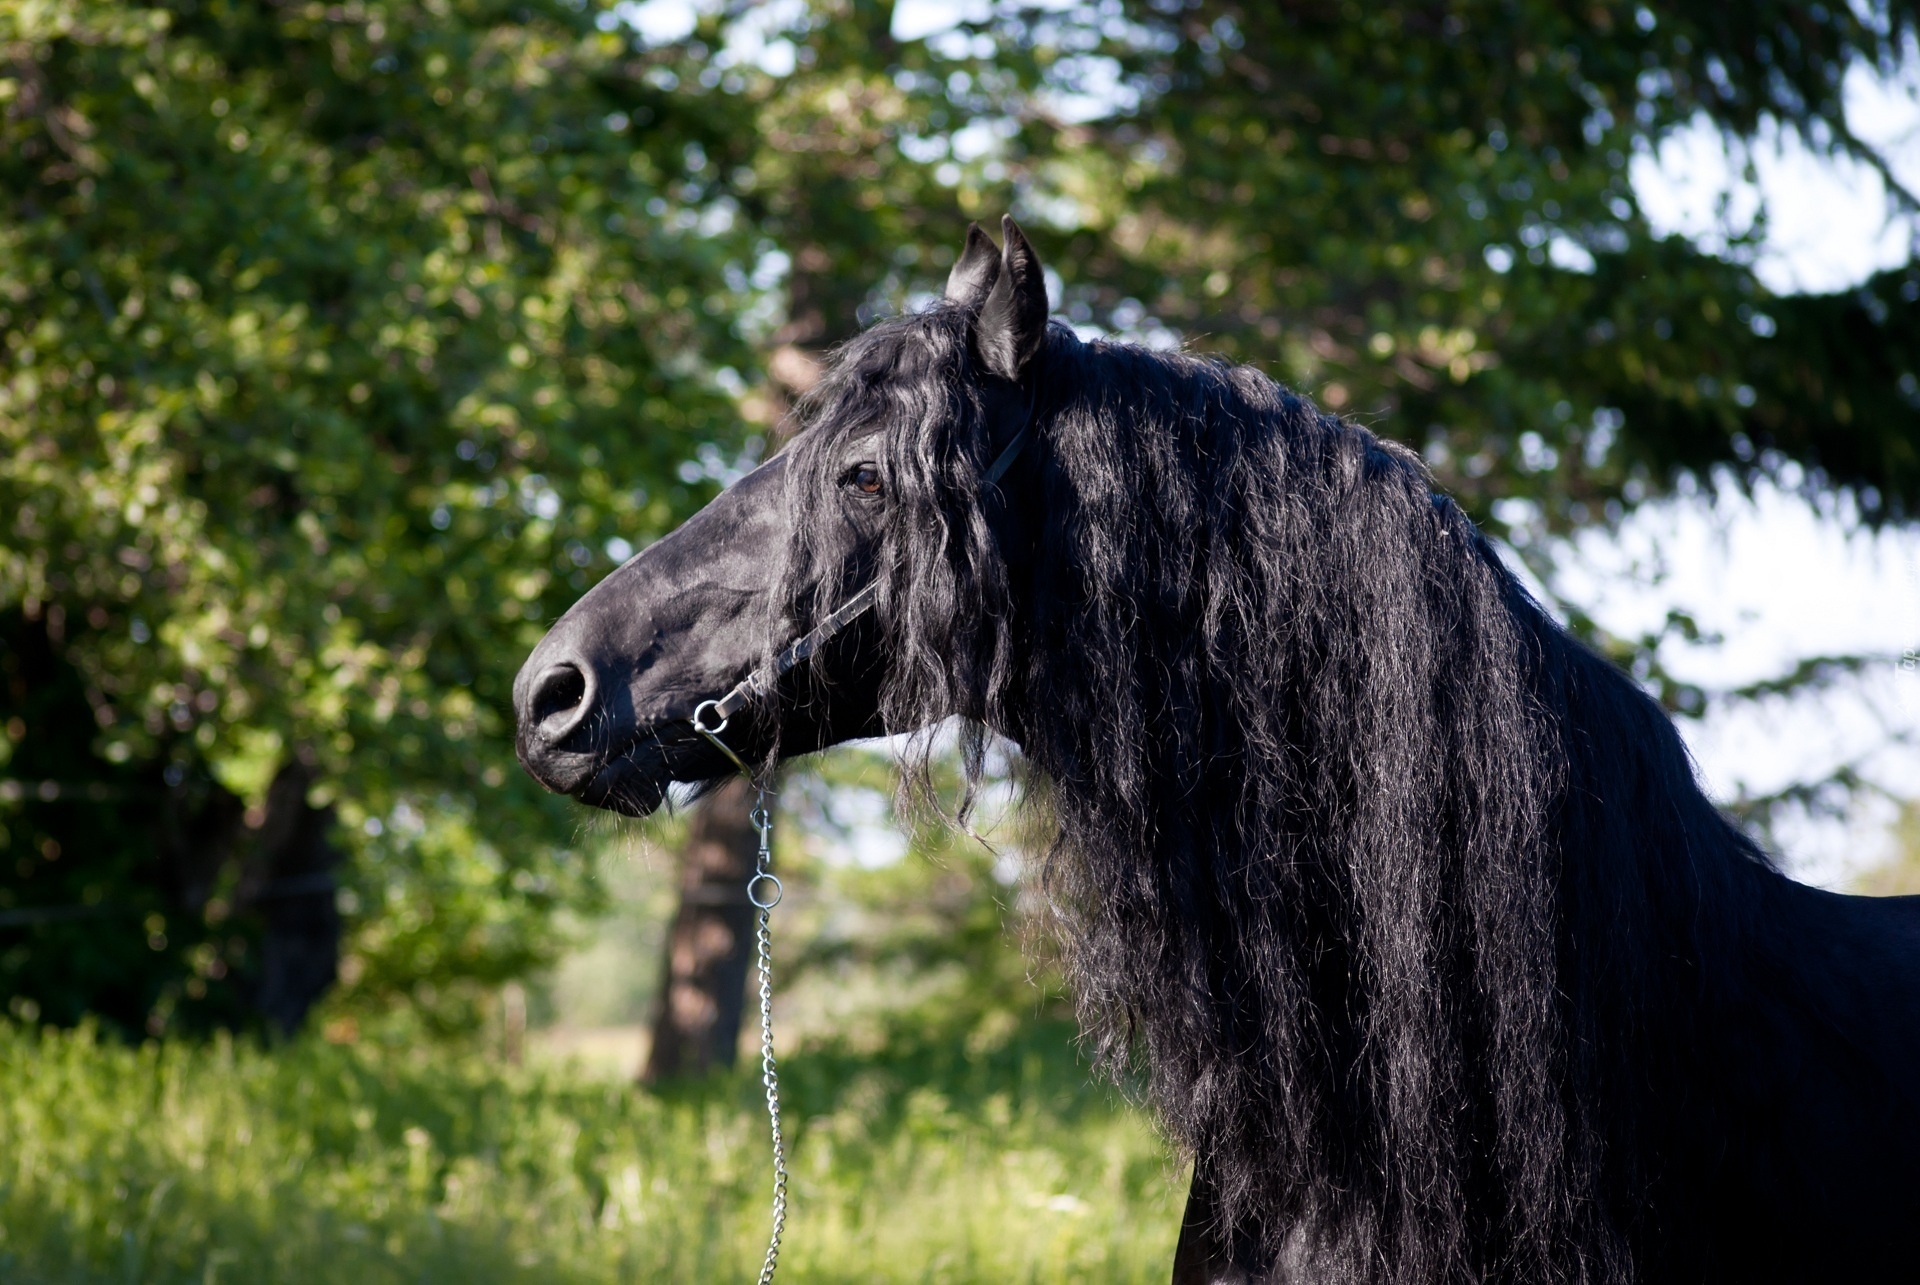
left=0, top=1022, right=1183, bottom=1285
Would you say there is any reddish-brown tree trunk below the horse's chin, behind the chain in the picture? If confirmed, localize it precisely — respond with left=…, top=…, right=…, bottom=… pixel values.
left=641, top=780, right=758, bottom=1083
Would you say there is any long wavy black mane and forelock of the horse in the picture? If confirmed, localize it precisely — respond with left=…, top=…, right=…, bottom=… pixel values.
left=775, top=307, right=1774, bottom=1285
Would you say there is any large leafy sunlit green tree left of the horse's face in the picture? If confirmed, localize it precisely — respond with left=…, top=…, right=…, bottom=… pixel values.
left=0, top=0, right=755, bottom=1026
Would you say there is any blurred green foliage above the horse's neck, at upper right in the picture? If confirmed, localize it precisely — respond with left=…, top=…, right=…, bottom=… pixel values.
left=675, top=0, right=1920, bottom=540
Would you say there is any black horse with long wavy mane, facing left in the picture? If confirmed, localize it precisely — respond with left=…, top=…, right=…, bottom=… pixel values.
left=515, top=221, right=1920, bottom=1285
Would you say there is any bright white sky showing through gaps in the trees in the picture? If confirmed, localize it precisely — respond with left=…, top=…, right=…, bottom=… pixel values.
left=622, top=0, right=1920, bottom=887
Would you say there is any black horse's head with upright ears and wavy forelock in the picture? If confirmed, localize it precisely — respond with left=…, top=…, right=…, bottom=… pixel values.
left=513, top=219, right=1046, bottom=816
